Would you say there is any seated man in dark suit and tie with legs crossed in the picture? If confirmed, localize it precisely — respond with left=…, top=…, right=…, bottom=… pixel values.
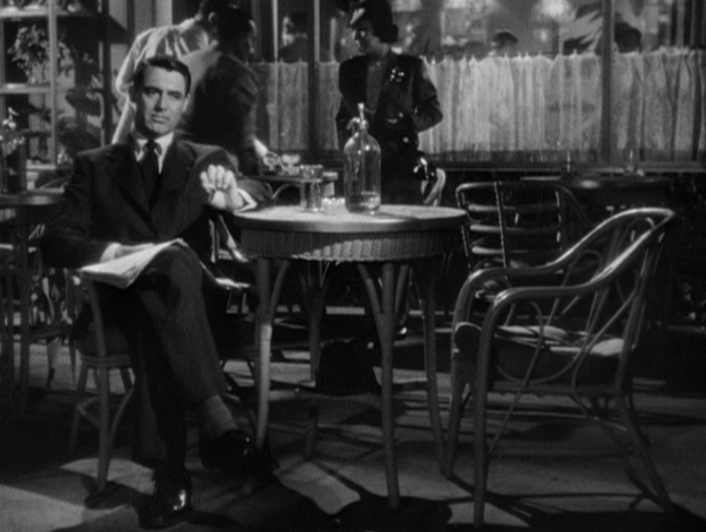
left=42, top=56, right=265, bottom=527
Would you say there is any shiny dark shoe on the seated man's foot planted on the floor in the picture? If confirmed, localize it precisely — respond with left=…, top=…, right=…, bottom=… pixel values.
left=139, top=471, right=192, bottom=529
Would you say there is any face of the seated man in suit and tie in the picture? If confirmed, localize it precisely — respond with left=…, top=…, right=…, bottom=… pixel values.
left=130, top=67, right=188, bottom=138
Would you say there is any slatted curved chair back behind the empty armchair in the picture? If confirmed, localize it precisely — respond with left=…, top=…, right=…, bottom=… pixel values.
left=455, top=181, right=589, bottom=271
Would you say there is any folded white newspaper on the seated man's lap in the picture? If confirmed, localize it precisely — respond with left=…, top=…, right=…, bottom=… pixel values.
left=79, top=238, right=188, bottom=288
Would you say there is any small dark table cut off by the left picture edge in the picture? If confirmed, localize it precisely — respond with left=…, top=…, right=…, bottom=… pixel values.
left=0, top=188, right=63, bottom=414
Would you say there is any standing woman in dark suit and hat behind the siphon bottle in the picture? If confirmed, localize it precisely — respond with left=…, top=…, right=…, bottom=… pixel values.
left=336, top=0, right=443, bottom=203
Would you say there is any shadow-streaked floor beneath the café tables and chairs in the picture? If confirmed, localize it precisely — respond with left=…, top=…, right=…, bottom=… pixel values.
left=0, top=330, right=706, bottom=532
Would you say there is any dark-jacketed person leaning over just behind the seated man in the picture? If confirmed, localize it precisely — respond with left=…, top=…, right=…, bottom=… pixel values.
left=179, top=6, right=278, bottom=175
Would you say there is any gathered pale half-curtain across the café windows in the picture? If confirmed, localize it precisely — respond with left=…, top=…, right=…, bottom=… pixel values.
left=256, top=49, right=706, bottom=162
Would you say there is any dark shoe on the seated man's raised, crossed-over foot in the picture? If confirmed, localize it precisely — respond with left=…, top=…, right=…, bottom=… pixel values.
left=199, top=430, right=272, bottom=476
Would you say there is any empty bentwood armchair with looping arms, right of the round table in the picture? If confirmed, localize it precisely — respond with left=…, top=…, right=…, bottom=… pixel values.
left=447, top=207, right=675, bottom=526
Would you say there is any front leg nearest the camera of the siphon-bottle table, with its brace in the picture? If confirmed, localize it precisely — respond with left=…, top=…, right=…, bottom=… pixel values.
left=358, top=262, right=400, bottom=508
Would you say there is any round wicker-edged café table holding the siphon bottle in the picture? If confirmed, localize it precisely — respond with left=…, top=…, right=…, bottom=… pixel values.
left=228, top=205, right=465, bottom=508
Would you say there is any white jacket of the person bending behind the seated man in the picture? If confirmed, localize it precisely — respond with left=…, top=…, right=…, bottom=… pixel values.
left=112, top=0, right=234, bottom=142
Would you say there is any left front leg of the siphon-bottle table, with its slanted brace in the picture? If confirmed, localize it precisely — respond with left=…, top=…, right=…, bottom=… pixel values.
left=255, top=258, right=289, bottom=449
